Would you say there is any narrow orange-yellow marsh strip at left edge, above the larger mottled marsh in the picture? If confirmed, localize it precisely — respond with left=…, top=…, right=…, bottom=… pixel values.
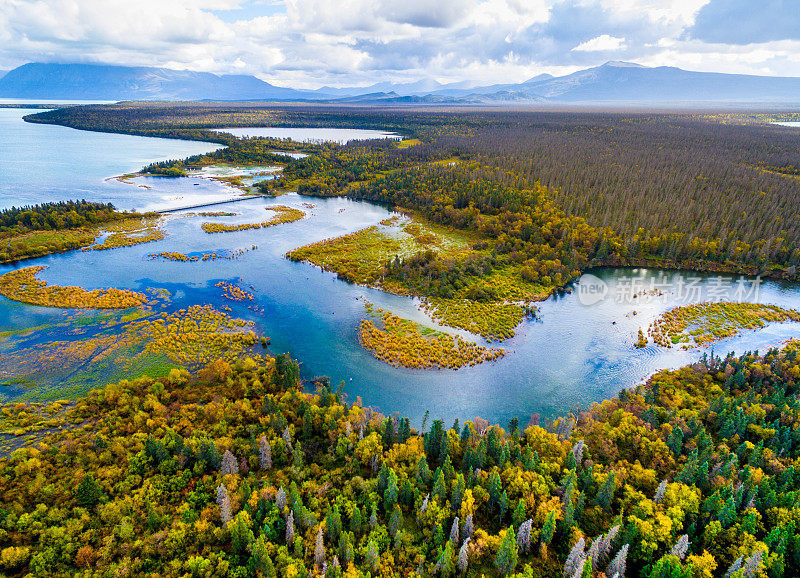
left=0, top=265, right=147, bottom=309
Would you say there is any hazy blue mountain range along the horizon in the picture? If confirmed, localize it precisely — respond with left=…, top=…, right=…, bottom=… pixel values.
left=0, top=62, right=800, bottom=104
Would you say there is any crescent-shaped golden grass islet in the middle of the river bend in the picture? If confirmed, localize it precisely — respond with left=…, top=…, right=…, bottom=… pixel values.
left=359, top=307, right=504, bottom=369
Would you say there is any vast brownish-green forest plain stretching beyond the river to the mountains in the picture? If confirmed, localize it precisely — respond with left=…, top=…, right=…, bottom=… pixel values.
left=26, top=103, right=800, bottom=281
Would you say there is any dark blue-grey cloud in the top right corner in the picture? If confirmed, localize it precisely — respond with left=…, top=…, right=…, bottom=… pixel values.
left=687, top=0, right=800, bottom=44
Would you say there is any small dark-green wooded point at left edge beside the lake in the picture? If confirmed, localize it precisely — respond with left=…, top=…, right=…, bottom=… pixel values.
left=0, top=200, right=121, bottom=236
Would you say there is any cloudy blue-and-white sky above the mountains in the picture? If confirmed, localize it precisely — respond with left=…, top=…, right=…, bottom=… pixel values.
left=0, top=0, right=800, bottom=88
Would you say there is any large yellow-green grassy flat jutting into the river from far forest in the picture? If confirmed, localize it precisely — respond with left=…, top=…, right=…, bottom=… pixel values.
left=287, top=214, right=549, bottom=340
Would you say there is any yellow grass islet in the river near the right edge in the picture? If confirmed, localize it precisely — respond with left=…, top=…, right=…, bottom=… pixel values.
left=640, top=303, right=800, bottom=347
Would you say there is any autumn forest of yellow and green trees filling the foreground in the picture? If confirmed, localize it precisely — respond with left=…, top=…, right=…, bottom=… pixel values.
left=0, top=344, right=800, bottom=578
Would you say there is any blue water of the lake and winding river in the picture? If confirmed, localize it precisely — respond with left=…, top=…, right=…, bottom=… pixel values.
left=0, top=110, right=800, bottom=425
